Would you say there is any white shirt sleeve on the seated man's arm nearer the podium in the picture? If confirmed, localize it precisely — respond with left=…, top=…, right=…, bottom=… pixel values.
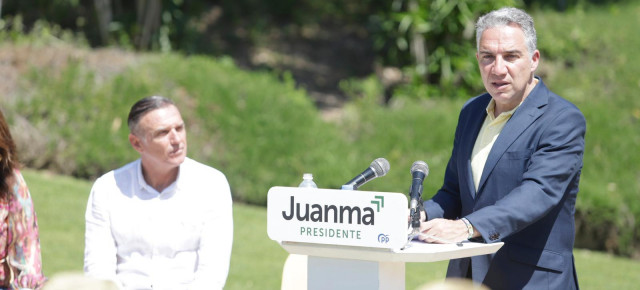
left=193, top=175, right=233, bottom=289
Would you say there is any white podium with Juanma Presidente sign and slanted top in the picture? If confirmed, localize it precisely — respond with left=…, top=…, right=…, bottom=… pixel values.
left=267, top=187, right=503, bottom=290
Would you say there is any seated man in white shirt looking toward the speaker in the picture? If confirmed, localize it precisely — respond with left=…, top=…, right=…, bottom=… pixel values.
left=84, top=96, right=233, bottom=289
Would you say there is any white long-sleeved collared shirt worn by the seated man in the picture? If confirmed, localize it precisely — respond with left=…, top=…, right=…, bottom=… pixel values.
left=84, top=158, right=233, bottom=289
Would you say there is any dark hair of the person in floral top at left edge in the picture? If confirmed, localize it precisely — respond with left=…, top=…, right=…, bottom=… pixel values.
left=0, top=111, right=20, bottom=199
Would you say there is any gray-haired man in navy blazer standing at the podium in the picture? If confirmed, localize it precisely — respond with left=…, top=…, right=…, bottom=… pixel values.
left=420, top=8, right=586, bottom=289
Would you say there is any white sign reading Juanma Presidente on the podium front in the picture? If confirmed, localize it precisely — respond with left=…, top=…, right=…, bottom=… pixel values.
left=267, top=187, right=408, bottom=249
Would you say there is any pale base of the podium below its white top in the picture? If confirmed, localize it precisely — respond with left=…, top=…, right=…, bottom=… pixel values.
left=307, top=256, right=405, bottom=290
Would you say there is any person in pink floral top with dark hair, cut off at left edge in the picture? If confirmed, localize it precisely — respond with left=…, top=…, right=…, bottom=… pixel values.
left=0, top=112, right=46, bottom=289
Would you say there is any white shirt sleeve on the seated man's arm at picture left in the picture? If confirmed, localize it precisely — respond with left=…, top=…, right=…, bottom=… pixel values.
left=84, top=179, right=117, bottom=281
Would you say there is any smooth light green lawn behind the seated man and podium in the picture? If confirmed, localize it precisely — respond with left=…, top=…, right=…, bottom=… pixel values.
left=23, top=170, right=640, bottom=290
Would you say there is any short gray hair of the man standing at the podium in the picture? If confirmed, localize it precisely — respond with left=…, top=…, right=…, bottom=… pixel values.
left=476, top=7, right=538, bottom=56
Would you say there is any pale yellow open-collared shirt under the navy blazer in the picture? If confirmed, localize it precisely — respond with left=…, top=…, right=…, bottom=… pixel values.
left=471, top=99, right=520, bottom=190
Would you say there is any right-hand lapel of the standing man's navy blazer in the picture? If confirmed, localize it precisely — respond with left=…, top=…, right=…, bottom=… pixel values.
left=478, top=80, right=549, bottom=193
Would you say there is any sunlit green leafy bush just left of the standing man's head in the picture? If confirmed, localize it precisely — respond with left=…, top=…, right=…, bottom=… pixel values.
left=375, top=0, right=517, bottom=95
